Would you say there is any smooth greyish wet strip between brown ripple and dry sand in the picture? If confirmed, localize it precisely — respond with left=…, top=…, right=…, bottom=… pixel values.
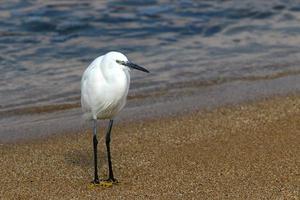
left=0, top=74, right=300, bottom=143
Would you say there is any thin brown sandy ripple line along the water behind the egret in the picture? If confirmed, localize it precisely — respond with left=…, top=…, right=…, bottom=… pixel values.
left=0, top=70, right=300, bottom=117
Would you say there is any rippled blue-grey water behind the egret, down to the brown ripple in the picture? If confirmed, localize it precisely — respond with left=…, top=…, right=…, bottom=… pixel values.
left=0, top=0, right=300, bottom=141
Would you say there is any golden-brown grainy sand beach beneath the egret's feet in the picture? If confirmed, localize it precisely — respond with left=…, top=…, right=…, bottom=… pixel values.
left=0, top=95, right=300, bottom=199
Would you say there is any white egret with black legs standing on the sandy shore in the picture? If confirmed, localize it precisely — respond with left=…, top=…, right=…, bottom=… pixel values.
left=81, top=51, right=149, bottom=184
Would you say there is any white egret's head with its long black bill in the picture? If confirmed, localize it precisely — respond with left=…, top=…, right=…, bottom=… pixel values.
left=106, top=51, right=149, bottom=73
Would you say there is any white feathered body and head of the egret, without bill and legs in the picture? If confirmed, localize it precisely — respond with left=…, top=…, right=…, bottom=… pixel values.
left=81, top=52, right=130, bottom=119
